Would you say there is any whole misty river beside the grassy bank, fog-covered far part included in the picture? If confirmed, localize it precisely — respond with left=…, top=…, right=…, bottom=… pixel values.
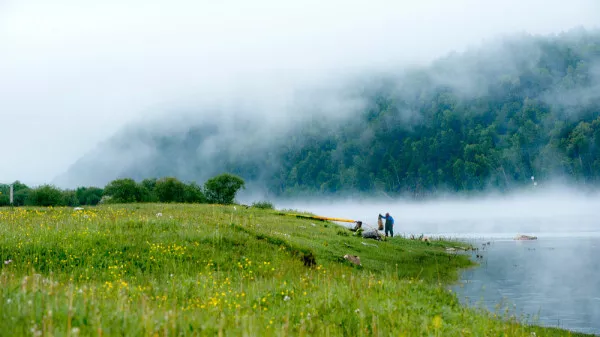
left=276, top=190, right=600, bottom=335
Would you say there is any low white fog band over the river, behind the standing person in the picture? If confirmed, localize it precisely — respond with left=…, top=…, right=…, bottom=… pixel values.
left=275, top=184, right=600, bottom=239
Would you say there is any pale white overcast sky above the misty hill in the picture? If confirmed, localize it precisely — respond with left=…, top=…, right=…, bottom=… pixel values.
left=0, top=0, right=600, bottom=185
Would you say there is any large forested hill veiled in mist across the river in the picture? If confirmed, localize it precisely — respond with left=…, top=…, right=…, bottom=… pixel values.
left=57, top=30, right=600, bottom=195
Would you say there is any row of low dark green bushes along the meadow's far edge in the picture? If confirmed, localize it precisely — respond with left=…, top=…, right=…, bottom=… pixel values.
left=0, top=173, right=245, bottom=207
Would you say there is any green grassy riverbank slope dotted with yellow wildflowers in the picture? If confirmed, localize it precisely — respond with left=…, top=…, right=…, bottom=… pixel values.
left=0, top=205, right=592, bottom=336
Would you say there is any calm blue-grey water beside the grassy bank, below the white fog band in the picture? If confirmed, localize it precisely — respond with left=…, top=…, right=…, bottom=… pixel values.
left=454, top=233, right=600, bottom=334
